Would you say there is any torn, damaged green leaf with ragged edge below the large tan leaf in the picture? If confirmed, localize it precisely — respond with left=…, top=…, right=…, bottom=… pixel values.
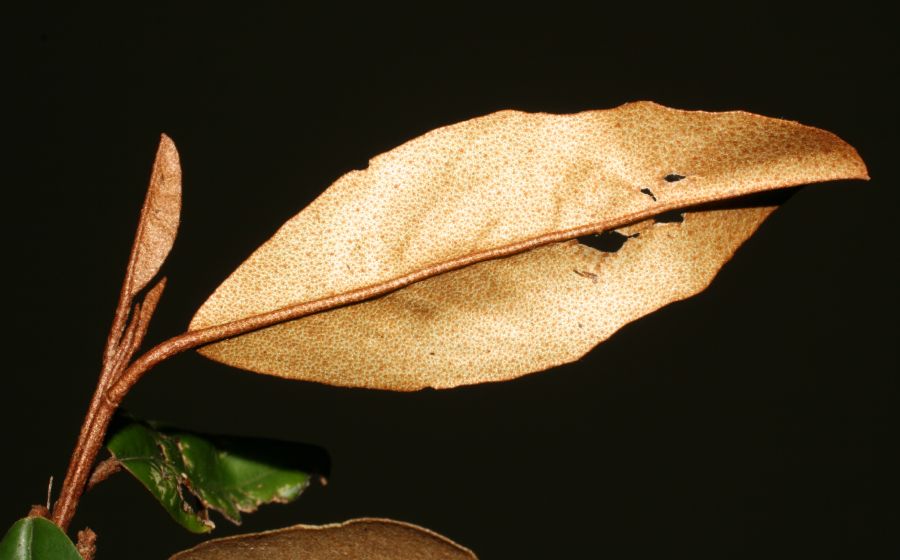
left=107, top=422, right=327, bottom=533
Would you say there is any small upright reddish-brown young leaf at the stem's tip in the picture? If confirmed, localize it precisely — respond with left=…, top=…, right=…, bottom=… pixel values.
left=126, top=134, right=181, bottom=297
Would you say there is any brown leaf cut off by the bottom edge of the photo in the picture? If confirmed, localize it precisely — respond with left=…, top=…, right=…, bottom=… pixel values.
left=170, top=519, right=476, bottom=560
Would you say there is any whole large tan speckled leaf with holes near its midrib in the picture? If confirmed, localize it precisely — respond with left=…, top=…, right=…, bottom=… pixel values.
left=191, top=103, right=866, bottom=390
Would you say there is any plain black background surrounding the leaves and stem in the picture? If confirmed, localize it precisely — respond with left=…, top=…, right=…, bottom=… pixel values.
left=7, top=2, right=900, bottom=559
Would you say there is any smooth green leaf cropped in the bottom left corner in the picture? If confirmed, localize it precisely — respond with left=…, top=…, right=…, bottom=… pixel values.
left=0, top=517, right=82, bottom=560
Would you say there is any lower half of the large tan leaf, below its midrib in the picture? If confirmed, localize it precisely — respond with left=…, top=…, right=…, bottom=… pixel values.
left=203, top=208, right=772, bottom=390
